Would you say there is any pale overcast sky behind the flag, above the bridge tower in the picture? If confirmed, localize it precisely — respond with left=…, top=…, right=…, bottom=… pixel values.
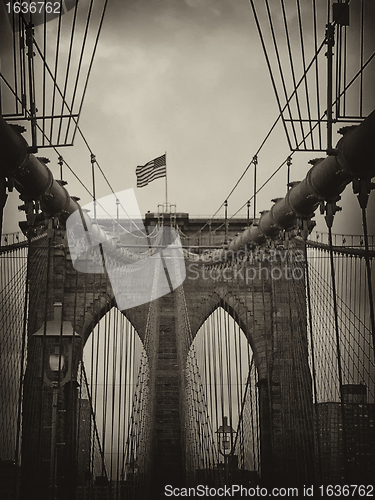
left=0, top=0, right=375, bottom=233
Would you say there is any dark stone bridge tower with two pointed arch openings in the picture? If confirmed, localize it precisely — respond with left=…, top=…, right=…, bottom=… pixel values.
left=22, top=214, right=314, bottom=500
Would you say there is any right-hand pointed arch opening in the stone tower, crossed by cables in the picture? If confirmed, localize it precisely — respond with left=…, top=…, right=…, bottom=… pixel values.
left=185, top=299, right=260, bottom=474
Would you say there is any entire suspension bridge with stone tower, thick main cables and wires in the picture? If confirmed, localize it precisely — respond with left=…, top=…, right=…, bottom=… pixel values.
left=0, top=0, right=375, bottom=500
